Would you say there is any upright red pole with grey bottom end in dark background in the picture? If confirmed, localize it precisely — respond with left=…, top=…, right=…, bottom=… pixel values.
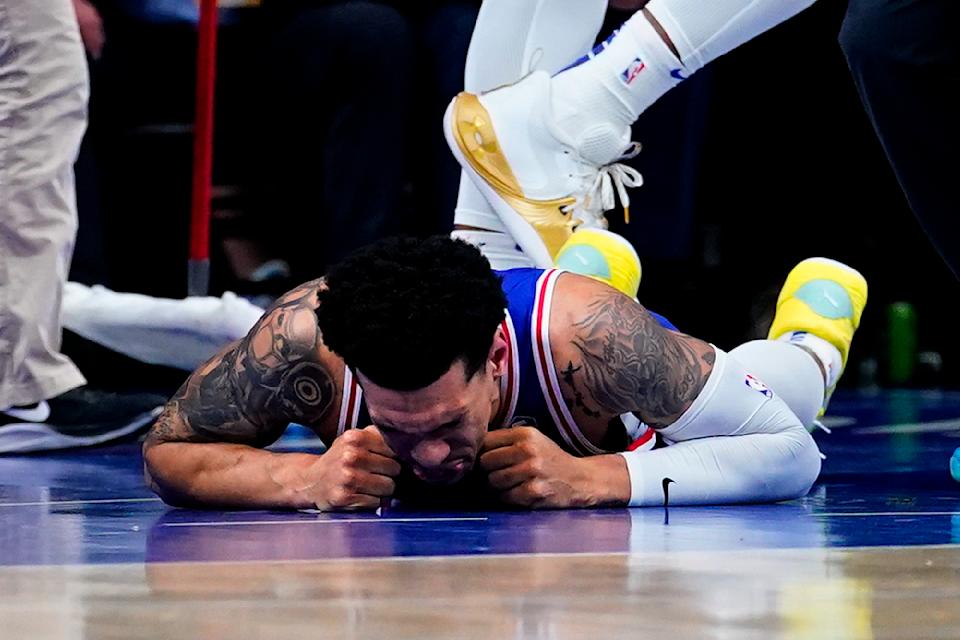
left=187, top=0, right=217, bottom=296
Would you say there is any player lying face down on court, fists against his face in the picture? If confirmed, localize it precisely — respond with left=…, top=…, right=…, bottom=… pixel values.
left=144, top=237, right=866, bottom=510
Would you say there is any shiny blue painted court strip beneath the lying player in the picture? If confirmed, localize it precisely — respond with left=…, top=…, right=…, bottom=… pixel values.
left=0, top=391, right=960, bottom=566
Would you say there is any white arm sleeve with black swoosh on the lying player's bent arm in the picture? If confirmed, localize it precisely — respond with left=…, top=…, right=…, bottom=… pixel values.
left=620, top=349, right=820, bottom=506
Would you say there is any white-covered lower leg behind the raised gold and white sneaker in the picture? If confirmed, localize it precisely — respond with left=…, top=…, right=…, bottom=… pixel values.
left=454, top=0, right=607, bottom=238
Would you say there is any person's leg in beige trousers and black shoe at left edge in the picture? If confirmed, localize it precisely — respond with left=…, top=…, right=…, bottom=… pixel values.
left=0, top=0, right=162, bottom=453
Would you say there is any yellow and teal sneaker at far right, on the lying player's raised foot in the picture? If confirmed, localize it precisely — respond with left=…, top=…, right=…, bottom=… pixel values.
left=768, top=258, right=867, bottom=416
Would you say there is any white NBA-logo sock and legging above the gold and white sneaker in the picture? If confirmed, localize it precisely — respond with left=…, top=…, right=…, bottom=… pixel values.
left=553, top=0, right=814, bottom=140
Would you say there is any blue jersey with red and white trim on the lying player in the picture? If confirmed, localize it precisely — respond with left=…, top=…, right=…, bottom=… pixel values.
left=337, top=269, right=676, bottom=456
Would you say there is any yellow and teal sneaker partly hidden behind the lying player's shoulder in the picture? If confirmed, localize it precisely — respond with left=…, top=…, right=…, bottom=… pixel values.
left=556, top=227, right=643, bottom=298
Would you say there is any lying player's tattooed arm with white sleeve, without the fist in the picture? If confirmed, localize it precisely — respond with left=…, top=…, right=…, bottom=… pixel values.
left=551, top=275, right=820, bottom=506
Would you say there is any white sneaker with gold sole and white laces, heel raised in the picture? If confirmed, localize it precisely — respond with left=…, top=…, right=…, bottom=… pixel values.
left=444, top=71, right=643, bottom=268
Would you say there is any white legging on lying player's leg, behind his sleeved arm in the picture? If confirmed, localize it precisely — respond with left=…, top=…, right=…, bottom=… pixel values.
left=730, top=340, right=824, bottom=428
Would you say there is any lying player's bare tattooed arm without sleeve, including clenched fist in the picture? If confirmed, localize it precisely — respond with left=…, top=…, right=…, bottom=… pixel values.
left=144, top=281, right=395, bottom=508
